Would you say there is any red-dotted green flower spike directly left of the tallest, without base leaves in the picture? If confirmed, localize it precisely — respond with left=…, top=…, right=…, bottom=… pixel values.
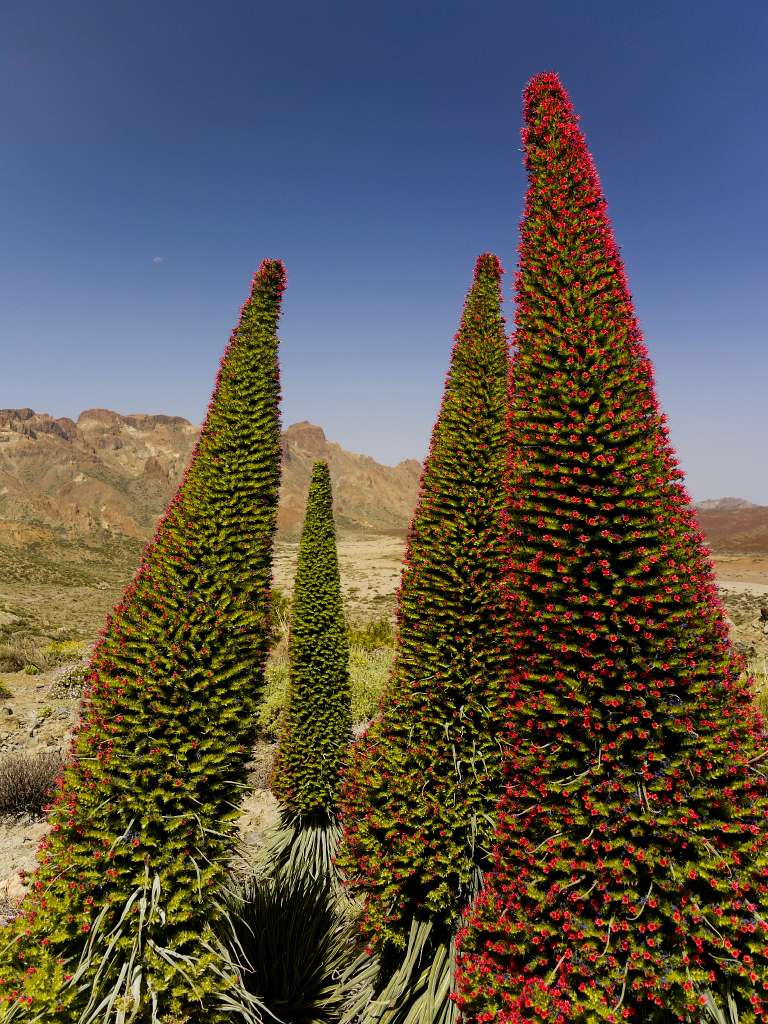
left=339, top=254, right=509, bottom=959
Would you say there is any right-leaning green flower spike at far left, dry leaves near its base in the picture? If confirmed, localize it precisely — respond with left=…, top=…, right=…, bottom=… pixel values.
left=0, top=260, right=285, bottom=1022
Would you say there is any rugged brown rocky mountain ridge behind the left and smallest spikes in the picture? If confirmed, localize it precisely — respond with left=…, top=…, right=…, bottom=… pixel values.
left=0, top=409, right=421, bottom=547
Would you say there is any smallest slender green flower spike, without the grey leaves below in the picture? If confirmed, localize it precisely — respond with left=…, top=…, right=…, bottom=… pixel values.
left=272, top=462, right=352, bottom=820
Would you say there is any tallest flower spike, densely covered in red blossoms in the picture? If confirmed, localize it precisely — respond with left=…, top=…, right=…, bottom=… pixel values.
left=459, top=74, right=768, bottom=1024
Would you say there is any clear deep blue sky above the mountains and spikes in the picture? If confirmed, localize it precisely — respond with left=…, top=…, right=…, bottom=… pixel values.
left=0, top=0, right=768, bottom=504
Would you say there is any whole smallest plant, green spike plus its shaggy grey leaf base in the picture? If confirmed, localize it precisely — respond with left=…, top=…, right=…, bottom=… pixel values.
left=222, top=462, right=361, bottom=1024
